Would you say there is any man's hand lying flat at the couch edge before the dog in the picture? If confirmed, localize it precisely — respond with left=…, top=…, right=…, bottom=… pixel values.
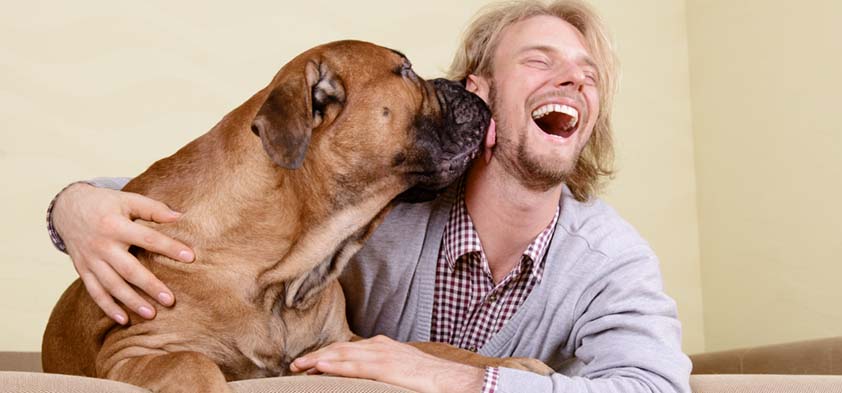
left=290, top=336, right=485, bottom=393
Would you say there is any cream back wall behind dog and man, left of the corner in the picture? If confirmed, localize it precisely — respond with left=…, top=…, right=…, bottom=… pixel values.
left=0, top=0, right=705, bottom=352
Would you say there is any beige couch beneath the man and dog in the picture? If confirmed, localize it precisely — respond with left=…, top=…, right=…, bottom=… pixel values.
left=0, top=337, right=842, bottom=393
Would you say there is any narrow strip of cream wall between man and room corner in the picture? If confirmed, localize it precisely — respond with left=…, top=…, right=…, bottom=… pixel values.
left=594, top=0, right=705, bottom=353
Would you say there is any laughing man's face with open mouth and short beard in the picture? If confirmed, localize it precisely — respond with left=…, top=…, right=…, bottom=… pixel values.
left=477, top=16, right=599, bottom=191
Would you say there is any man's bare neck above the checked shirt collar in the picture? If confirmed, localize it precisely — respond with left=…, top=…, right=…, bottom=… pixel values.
left=465, top=159, right=562, bottom=283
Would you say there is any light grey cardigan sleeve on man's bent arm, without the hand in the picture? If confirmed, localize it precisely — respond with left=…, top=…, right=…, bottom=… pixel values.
left=497, top=247, right=691, bottom=393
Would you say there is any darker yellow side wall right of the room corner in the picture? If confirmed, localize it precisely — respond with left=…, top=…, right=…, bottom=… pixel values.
left=688, top=0, right=842, bottom=350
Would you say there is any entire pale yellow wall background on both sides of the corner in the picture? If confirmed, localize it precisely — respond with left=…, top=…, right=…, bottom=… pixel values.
left=0, top=0, right=842, bottom=353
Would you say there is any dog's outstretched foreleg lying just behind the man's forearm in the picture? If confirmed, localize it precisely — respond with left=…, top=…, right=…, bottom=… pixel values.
left=409, top=342, right=555, bottom=375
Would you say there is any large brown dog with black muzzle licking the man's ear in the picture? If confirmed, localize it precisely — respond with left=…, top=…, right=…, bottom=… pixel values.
left=42, top=41, right=545, bottom=392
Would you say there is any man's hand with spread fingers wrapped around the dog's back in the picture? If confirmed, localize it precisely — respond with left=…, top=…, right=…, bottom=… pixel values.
left=53, top=183, right=194, bottom=324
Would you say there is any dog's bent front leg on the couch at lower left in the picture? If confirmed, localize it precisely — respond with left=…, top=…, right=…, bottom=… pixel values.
left=106, top=352, right=231, bottom=393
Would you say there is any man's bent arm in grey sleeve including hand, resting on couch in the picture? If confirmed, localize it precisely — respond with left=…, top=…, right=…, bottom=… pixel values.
left=292, top=247, right=691, bottom=393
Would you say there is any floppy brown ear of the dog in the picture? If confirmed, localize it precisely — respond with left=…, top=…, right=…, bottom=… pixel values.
left=251, top=60, right=345, bottom=169
